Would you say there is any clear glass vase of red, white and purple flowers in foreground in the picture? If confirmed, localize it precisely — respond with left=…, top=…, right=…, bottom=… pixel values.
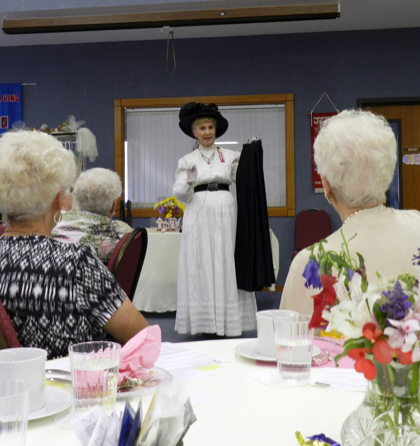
left=303, top=234, right=420, bottom=446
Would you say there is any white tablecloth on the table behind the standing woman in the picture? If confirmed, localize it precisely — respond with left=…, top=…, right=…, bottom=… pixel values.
left=133, top=229, right=280, bottom=313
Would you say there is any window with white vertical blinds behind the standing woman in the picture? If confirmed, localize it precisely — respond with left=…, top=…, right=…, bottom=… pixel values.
left=124, top=104, right=286, bottom=209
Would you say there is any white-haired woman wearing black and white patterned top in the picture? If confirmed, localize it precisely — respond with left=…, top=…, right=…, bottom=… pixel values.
left=0, top=131, right=148, bottom=359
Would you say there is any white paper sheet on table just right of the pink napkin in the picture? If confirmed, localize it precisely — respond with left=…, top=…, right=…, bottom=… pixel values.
left=156, top=342, right=228, bottom=372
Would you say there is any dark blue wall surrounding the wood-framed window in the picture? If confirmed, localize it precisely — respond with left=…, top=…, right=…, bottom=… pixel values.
left=0, top=28, right=420, bottom=284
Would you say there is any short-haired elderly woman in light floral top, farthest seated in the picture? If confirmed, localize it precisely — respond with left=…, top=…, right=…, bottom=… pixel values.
left=53, top=167, right=133, bottom=264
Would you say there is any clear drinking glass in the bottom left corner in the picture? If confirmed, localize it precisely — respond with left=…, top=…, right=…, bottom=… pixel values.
left=0, top=379, right=30, bottom=446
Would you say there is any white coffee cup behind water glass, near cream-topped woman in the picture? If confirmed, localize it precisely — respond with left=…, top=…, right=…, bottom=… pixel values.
left=256, top=310, right=298, bottom=359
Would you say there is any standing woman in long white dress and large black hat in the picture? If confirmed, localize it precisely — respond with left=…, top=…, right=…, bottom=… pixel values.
left=173, top=102, right=257, bottom=336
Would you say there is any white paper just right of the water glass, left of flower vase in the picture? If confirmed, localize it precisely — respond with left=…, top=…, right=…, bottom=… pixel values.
left=311, top=368, right=367, bottom=392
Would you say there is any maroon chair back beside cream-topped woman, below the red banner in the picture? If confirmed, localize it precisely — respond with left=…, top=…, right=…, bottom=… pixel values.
left=292, top=209, right=331, bottom=260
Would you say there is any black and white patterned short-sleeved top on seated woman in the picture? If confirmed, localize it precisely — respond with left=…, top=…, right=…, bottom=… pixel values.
left=0, top=236, right=126, bottom=359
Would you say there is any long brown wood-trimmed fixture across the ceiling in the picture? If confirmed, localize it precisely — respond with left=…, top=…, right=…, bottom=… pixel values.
left=2, top=0, right=340, bottom=34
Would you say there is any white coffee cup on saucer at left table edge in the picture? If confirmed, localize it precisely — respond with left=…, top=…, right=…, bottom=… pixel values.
left=0, top=347, right=47, bottom=412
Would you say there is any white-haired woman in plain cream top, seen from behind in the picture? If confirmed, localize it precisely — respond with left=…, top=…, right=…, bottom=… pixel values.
left=280, top=110, right=420, bottom=314
